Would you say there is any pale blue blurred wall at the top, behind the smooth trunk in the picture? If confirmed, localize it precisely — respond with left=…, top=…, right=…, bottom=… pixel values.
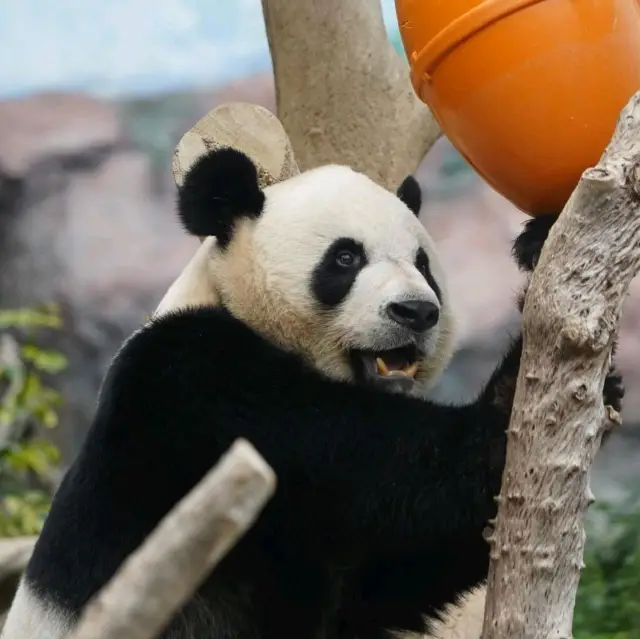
left=0, top=0, right=397, bottom=98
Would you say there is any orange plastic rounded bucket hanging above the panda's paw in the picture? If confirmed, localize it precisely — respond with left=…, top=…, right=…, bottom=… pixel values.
left=396, top=0, right=640, bottom=216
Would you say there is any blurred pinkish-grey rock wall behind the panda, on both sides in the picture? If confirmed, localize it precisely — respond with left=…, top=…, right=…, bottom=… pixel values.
left=0, top=76, right=640, bottom=500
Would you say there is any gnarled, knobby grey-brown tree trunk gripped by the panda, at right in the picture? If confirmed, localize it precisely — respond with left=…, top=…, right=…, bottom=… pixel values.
left=483, top=93, right=640, bottom=639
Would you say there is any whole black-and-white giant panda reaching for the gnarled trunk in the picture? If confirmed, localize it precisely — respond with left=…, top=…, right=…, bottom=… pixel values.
left=2, top=149, right=620, bottom=639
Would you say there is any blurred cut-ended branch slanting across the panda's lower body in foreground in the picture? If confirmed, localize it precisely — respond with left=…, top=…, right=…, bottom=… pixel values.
left=72, top=440, right=276, bottom=639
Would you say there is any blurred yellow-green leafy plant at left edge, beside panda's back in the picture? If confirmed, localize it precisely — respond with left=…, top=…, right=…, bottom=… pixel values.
left=0, top=306, right=67, bottom=537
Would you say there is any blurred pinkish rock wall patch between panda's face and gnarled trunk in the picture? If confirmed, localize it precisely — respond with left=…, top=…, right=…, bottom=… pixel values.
left=416, top=140, right=526, bottom=402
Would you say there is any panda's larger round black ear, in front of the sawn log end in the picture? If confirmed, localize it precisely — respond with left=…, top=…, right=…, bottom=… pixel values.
left=178, top=148, right=265, bottom=248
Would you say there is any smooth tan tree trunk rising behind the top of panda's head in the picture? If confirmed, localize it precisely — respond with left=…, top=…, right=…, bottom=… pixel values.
left=262, top=0, right=440, bottom=190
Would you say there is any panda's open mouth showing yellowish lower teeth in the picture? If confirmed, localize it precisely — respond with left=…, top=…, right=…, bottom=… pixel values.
left=351, top=345, right=421, bottom=390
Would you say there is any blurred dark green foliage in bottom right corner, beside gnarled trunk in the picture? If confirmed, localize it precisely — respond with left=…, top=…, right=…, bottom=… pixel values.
left=573, top=496, right=640, bottom=639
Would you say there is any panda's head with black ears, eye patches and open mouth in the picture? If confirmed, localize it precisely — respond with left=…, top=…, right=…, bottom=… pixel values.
left=178, top=148, right=453, bottom=395
